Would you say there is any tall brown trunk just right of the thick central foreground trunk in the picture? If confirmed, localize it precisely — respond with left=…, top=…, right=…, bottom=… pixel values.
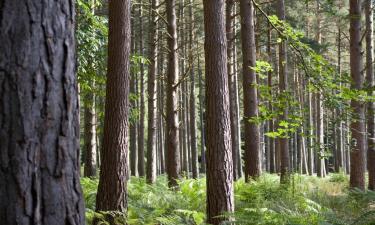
left=240, top=0, right=261, bottom=182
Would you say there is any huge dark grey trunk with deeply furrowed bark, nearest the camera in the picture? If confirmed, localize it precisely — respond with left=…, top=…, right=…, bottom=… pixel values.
left=0, top=0, right=84, bottom=225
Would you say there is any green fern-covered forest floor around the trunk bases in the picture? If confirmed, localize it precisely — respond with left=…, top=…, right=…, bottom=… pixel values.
left=82, top=174, right=375, bottom=225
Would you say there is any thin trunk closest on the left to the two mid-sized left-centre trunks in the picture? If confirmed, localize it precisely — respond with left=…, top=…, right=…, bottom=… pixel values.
left=138, top=4, right=145, bottom=177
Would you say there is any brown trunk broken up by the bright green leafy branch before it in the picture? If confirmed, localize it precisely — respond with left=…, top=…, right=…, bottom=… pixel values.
left=277, top=0, right=290, bottom=183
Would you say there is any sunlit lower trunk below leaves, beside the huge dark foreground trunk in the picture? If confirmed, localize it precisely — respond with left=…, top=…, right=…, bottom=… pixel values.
left=83, top=93, right=97, bottom=177
